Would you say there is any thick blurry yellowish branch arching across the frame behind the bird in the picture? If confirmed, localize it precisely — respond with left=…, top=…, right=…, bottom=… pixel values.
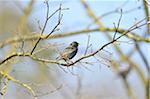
left=0, top=28, right=150, bottom=48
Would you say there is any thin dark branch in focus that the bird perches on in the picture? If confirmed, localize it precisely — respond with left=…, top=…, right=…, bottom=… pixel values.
left=0, top=18, right=149, bottom=67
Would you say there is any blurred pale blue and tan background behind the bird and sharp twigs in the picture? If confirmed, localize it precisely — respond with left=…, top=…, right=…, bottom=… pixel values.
left=0, top=0, right=150, bottom=99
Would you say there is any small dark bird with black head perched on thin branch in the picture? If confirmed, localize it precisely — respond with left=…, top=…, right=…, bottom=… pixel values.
left=56, top=41, right=79, bottom=62
